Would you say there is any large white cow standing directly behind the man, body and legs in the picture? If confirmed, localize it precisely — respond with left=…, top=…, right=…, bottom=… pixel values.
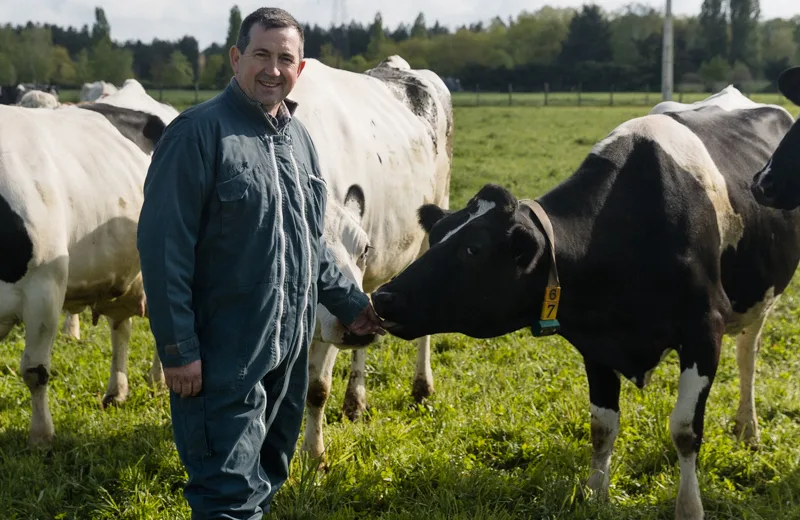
left=290, top=56, right=453, bottom=457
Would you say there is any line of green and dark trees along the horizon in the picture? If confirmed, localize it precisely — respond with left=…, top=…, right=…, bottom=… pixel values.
left=0, top=0, right=800, bottom=91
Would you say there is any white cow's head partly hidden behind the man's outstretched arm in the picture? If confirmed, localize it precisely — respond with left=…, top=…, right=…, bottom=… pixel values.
left=314, top=185, right=375, bottom=349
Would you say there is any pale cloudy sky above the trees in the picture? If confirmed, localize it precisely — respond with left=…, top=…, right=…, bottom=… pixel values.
left=0, top=0, right=800, bottom=50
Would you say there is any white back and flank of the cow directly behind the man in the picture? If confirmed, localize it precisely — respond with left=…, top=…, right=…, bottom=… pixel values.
left=290, top=59, right=452, bottom=290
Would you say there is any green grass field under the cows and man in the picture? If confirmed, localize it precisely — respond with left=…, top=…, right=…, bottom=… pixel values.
left=0, top=101, right=800, bottom=520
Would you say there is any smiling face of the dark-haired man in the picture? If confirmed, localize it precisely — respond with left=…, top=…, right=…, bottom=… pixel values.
left=231, top=23, right=305, bottom=115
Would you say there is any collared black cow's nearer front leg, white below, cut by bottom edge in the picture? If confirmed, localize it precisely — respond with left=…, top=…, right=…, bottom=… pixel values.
left=669, top=310, right=725, bottom=520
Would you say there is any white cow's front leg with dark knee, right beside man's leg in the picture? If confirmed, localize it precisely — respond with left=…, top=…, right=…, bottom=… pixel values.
left=302, top=341, right=339, bottom=458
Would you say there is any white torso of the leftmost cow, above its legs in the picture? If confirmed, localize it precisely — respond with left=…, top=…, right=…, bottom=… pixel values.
left=0, top=107, right=149, bottom=280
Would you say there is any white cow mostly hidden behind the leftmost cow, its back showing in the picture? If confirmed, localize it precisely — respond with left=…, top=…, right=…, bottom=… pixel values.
left=61, top=79, right=179, bottom=354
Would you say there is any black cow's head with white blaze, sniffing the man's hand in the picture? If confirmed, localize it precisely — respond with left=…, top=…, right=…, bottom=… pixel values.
left=372, top=184, right=550, bottom=339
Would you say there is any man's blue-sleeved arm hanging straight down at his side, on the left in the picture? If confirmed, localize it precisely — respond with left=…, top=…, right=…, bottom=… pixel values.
left=137, top=128, right=213, bottom=369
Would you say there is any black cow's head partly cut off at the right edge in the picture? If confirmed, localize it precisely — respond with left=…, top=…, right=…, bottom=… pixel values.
left=752, top=67, right=800, bottom=210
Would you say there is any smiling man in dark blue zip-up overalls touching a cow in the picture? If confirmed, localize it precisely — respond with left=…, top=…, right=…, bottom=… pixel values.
left=138, top=8, right=383, bottom=519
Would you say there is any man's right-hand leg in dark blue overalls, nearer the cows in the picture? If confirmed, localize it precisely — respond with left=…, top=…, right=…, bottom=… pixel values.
left=261, top=338, right=308, bottom=513
